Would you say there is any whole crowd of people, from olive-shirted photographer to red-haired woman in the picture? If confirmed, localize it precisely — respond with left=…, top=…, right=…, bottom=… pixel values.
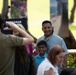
left=0, top=15, right=76, bottom=75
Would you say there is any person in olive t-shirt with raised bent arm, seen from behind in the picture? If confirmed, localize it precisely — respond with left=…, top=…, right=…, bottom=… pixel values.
left=0, top=15, right=34, bottom=75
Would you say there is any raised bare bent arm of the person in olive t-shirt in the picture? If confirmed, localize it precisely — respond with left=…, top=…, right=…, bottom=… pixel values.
left=6, top=22, right=34, bottom=45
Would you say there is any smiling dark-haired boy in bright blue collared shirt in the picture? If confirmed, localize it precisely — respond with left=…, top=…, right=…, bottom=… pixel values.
left=35, top=40, right=47, bottom=66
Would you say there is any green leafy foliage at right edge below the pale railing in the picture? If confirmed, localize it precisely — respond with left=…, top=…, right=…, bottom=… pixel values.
left=67, top=54, right=76, bottom=69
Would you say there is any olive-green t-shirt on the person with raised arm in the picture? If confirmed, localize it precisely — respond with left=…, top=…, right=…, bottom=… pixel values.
left=0, top=33, right=22, bottom=75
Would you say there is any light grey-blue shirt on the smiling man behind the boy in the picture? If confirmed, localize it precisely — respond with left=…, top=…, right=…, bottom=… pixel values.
left=37, top=33, right=68, bottom=54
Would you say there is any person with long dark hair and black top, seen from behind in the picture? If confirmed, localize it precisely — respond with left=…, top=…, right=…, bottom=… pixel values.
left=14, top=46, right=37, bottom=75
